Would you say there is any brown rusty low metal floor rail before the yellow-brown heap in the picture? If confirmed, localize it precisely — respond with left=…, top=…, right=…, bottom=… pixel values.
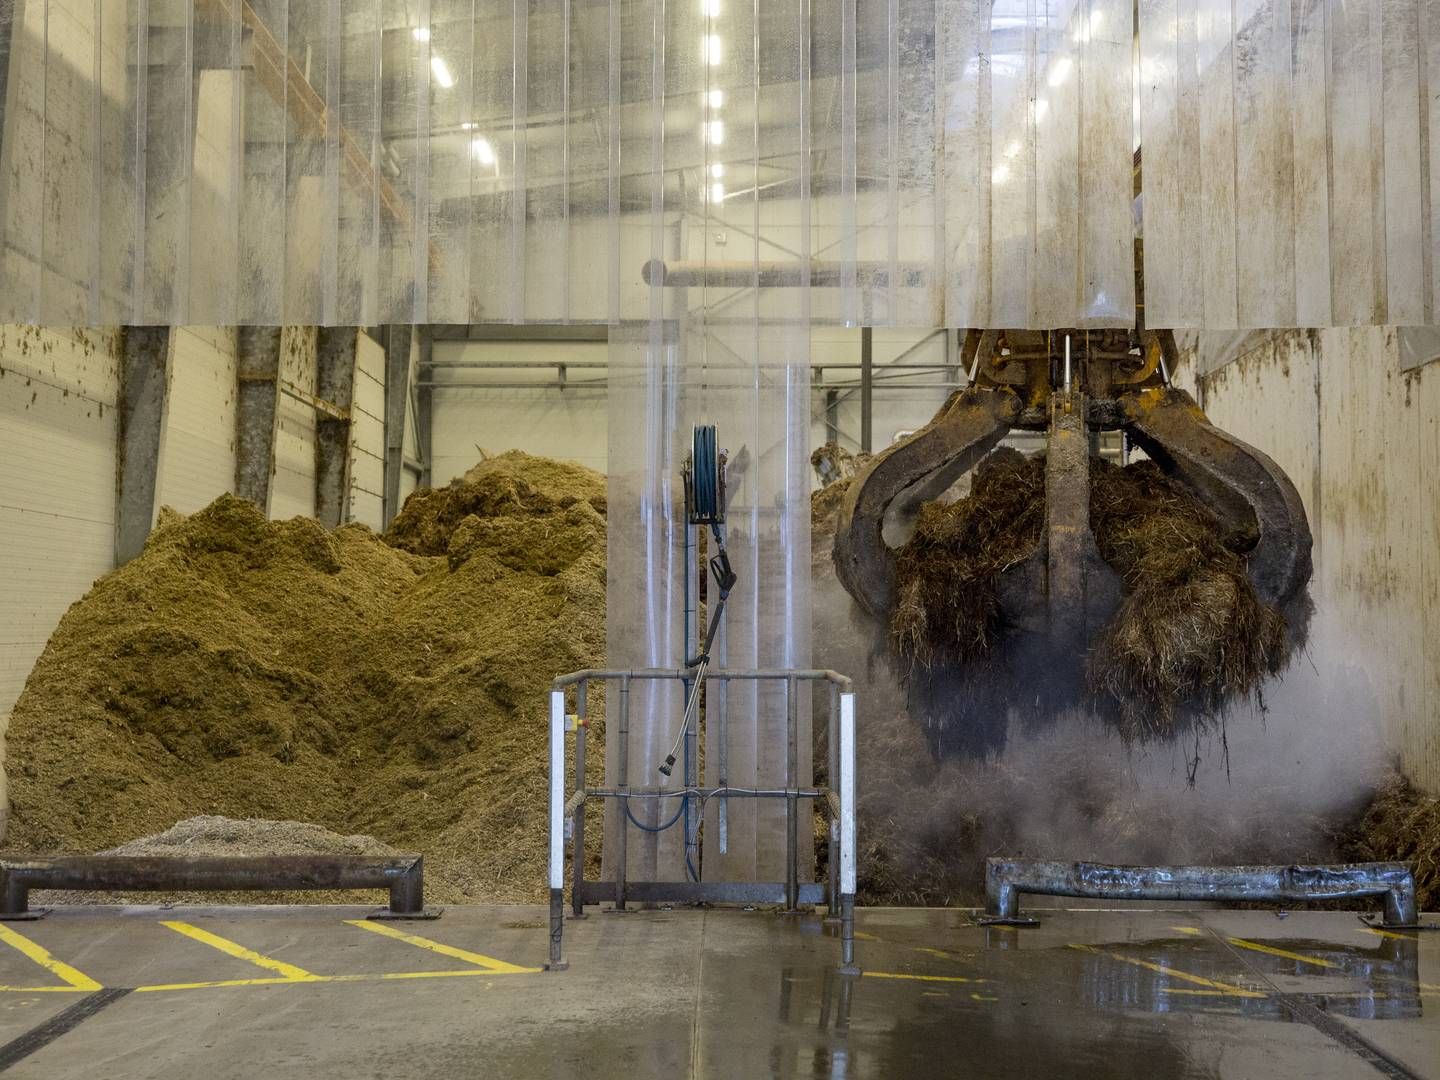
left=0, top=855, right=425, bottom=920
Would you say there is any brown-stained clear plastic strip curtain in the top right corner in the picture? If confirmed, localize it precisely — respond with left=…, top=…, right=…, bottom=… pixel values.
left=1138, top=0, right=1440, bottom=328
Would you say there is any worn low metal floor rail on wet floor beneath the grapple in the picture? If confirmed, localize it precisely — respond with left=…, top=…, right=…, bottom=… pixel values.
left=985, top=858, right=1420, bottom=927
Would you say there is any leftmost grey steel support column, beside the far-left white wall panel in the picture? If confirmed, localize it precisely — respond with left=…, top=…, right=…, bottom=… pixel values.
left=115, top=327, right=170, bottom=566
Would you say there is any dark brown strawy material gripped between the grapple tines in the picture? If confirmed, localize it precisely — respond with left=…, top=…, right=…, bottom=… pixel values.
left=890, top=451, right=1292, bottom=739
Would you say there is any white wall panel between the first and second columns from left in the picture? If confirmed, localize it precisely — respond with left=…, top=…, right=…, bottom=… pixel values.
left=156, top=327, right=236, bottom=514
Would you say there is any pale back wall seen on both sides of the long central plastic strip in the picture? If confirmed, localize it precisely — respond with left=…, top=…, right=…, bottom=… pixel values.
left=432, top=327, right=948, bottom=484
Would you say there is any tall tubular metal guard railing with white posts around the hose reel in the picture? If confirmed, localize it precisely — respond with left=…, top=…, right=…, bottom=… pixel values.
left=547, top=668, right=855, bottom=971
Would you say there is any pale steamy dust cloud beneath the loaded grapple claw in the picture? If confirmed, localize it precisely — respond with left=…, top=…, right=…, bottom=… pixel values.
left=815, top=570, right=1387, bottom=904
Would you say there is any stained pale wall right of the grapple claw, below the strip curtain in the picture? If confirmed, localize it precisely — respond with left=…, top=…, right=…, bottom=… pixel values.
left=1197, top=327, right=1440, bottom=792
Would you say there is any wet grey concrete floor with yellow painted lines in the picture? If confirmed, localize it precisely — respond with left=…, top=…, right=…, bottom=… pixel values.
left=0, top=907, right=1440, bottom=1080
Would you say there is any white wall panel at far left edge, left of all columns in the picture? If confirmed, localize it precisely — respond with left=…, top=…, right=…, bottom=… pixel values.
left=0, top=325, right=118, bottom=716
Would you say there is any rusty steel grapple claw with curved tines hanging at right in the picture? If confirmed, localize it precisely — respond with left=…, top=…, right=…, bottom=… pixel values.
left=834, top=331, right=1312, bottom=668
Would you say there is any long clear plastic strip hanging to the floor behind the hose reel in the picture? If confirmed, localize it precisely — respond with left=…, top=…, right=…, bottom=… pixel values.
left=606, top=0, right=821, bottom=881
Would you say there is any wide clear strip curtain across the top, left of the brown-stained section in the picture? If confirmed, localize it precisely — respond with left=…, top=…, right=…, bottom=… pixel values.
left=0, top=0, right=1133, bottom=327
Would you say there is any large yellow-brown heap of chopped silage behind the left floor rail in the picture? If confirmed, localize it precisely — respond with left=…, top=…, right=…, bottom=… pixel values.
left=4, top=454, right=605, bottom=901
